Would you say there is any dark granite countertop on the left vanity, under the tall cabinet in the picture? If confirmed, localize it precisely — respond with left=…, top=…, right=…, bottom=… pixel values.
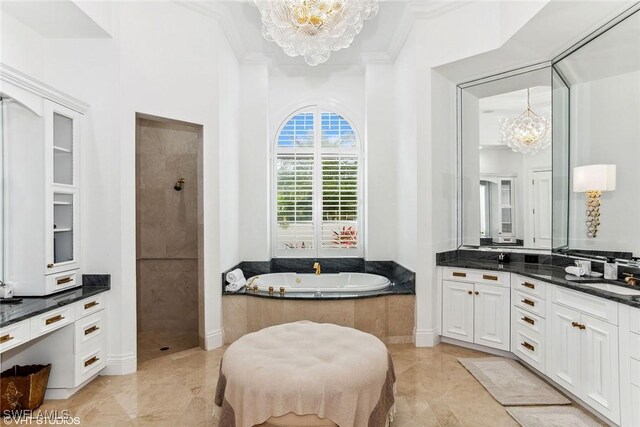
left=0, top=275, right=111, bottom=328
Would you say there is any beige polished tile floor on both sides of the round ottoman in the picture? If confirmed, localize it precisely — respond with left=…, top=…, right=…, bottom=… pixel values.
left=30, top=344, right=600, bottom=427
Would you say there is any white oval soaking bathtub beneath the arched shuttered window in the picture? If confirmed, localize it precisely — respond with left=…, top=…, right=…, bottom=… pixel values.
left=247, top=273, right=391, bottom=293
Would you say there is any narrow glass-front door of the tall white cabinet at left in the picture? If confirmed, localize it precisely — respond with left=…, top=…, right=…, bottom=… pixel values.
left=45, top=101, right=80, bottom=274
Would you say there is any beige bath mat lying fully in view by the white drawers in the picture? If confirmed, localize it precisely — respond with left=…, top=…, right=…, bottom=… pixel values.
left=458, top=357, right=571, bottom=406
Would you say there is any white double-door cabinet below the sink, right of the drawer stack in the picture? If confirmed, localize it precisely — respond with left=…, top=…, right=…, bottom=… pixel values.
left=546, top=286, right=620, bottom=423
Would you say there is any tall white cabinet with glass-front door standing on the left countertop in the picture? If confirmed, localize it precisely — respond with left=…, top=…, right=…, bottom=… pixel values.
left=4, top=99, right=82, bottom=296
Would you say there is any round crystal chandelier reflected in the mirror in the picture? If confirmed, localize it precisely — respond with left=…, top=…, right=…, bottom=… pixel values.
left=500, top=89, right=551, bottom=154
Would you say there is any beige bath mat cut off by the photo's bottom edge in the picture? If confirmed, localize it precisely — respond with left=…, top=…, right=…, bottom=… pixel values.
left=507, top=406, right=605, bottom=427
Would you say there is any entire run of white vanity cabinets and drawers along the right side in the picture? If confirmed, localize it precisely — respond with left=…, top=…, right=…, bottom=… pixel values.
left=442, top=267, right=628, bottom=427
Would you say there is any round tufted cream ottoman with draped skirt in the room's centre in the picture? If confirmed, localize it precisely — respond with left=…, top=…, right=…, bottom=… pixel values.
left=216, top=321, right=395, bottom=427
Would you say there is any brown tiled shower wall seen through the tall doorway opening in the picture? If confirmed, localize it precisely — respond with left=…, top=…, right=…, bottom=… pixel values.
left=136, top=118, right=202, bottom=336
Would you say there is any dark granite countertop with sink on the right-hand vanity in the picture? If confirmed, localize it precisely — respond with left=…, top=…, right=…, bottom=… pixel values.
left=437, top=259, right=640, bottom=308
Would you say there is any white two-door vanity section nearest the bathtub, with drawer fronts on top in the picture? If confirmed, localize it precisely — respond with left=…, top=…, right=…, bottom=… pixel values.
left=442, top=268, right=510, bottom=350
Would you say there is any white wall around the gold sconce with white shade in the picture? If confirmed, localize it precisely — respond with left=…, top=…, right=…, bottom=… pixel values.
left=569, top=72, right=640, bottom=256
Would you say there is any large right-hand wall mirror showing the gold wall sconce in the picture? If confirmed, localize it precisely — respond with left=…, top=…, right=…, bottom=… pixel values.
left=553, top=6, right=640, bottom=258
